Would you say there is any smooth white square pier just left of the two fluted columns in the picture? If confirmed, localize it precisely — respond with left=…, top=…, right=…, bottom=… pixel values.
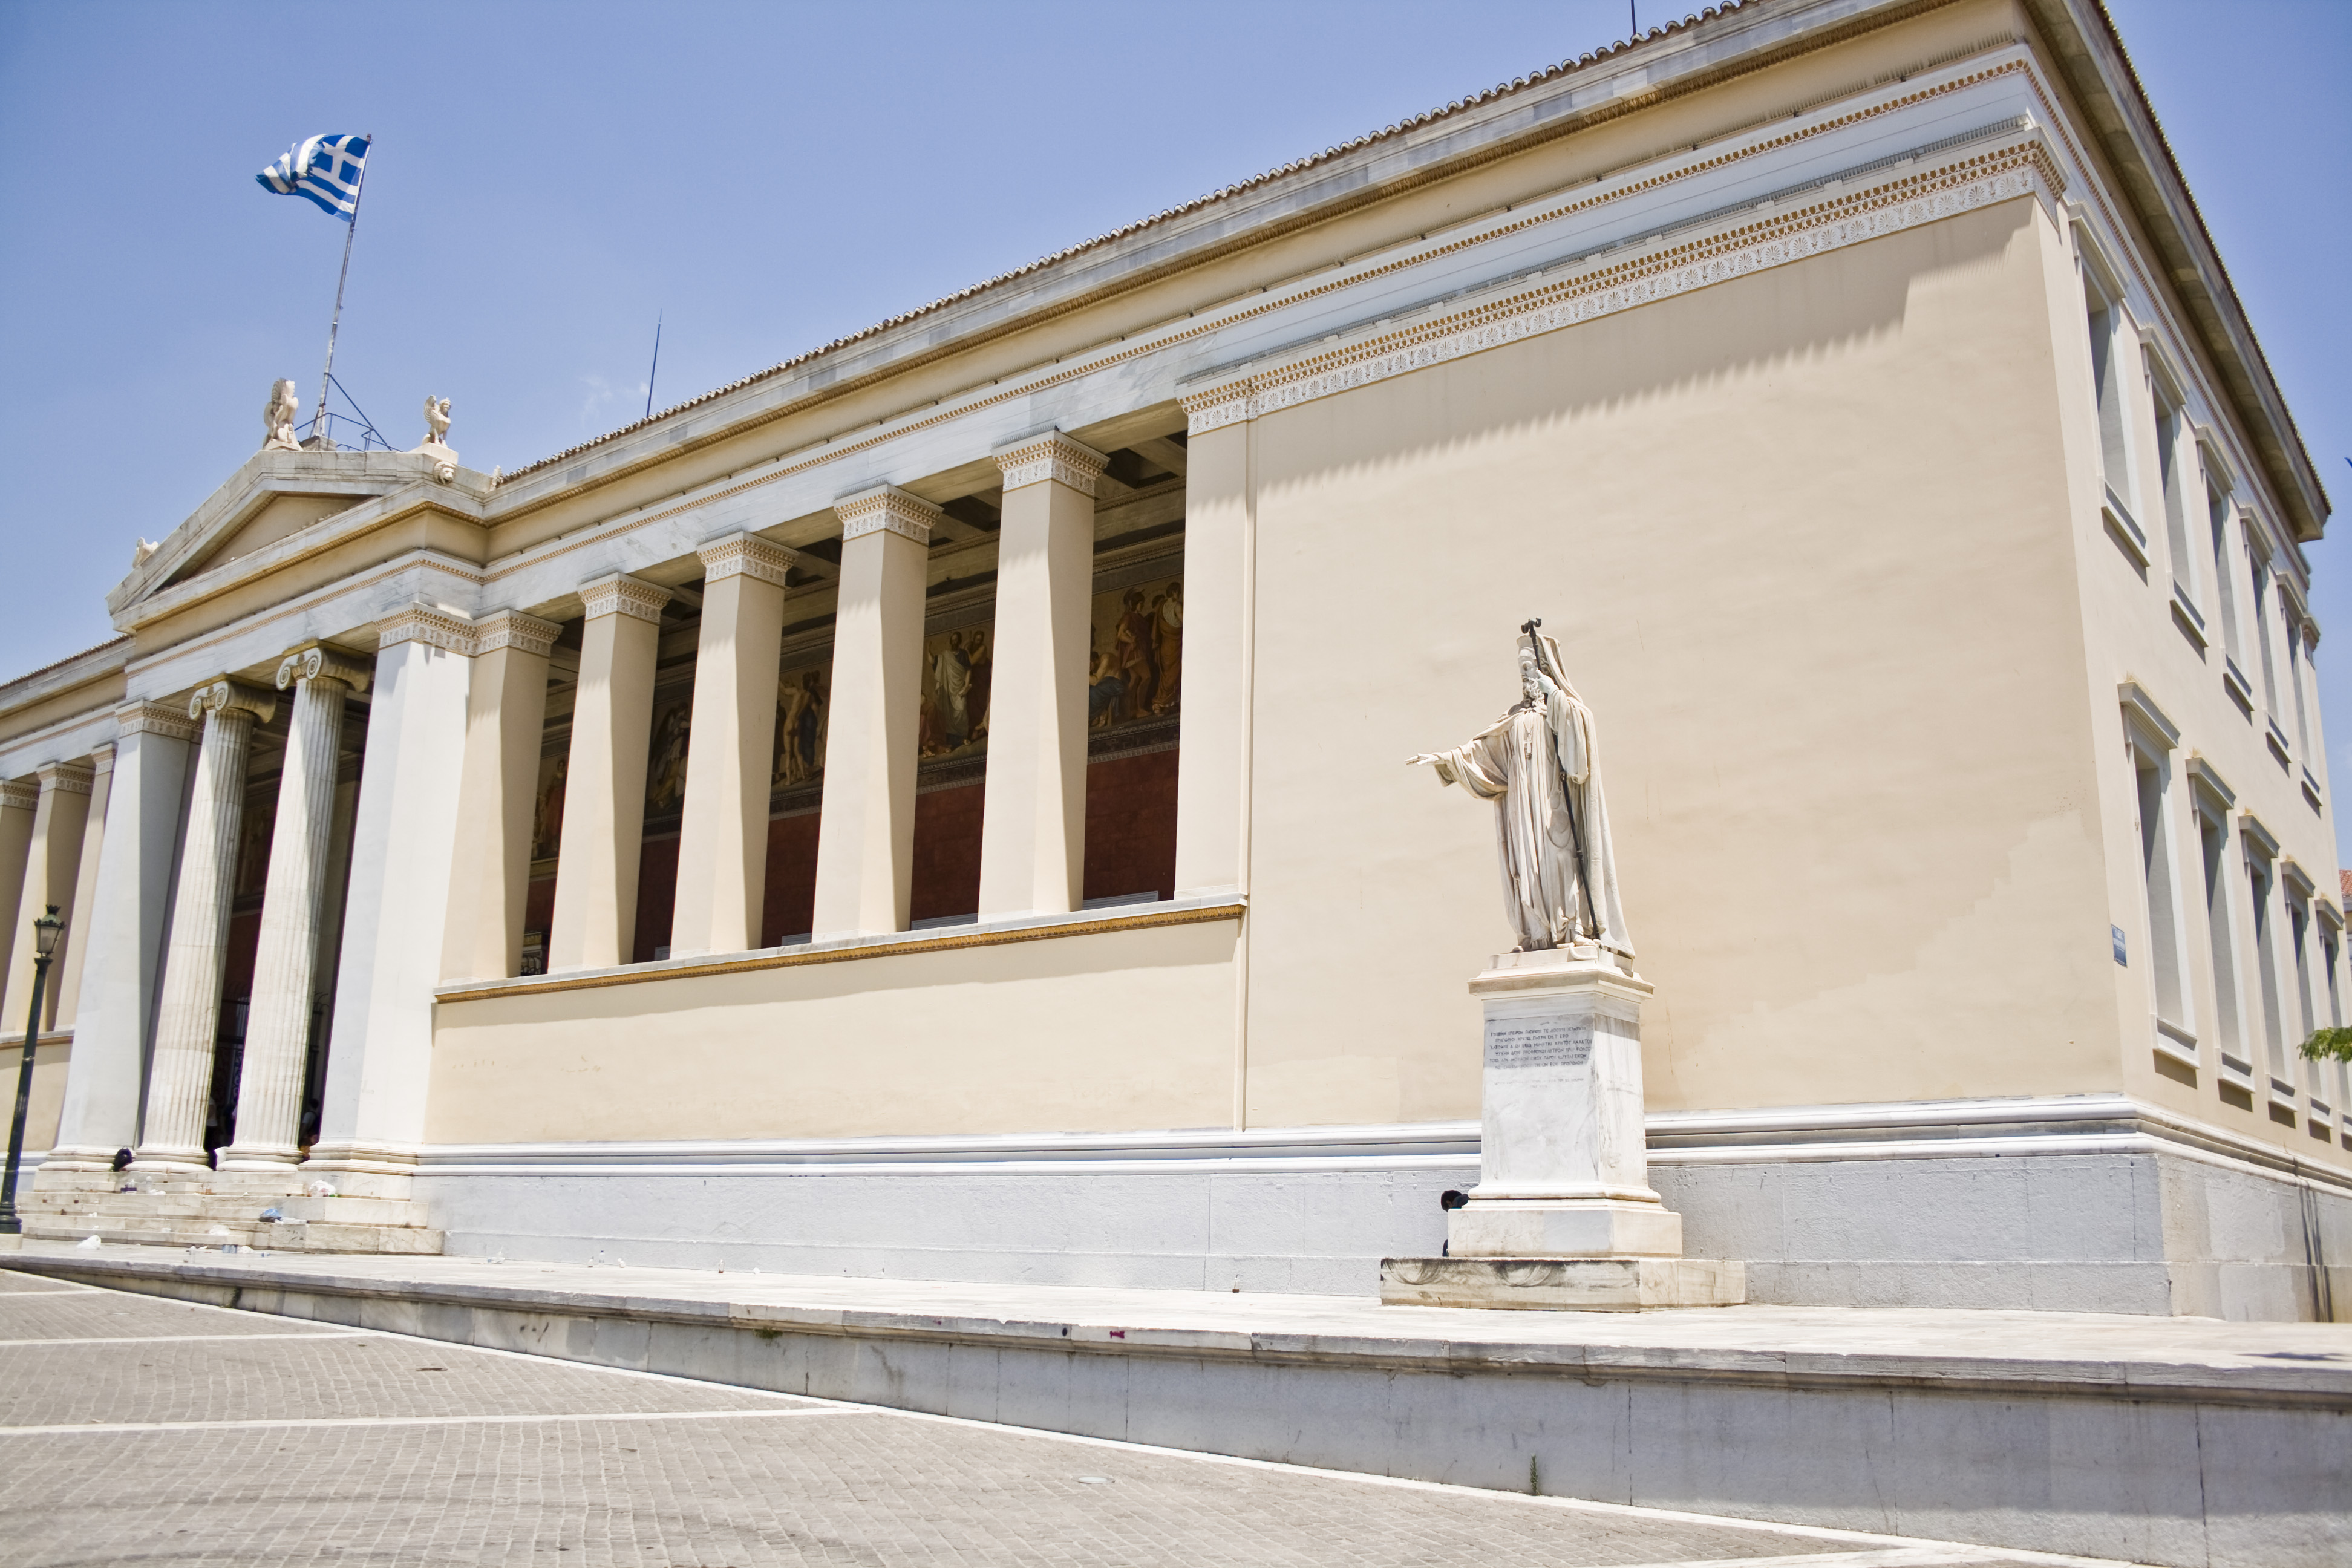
left=42, top=703, right=200, bottom=1171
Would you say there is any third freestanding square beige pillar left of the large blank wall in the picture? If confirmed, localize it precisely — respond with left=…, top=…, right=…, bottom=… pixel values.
left=670, top=534, right=792, bottom=957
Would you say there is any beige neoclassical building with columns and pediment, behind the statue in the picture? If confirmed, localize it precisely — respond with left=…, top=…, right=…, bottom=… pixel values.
left=0, top=0, right=2352, bottom=1316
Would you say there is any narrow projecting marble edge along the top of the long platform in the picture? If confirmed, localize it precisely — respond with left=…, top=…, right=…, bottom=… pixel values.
left=0, top=1241, right=2352, bottom=1411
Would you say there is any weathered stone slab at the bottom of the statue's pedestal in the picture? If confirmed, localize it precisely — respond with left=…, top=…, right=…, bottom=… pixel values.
left=1380, top=1258, right=1748, bottom=1312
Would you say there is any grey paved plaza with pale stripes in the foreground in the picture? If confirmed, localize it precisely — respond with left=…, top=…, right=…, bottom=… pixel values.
left=0, top=1272, right=2154, bottom=1568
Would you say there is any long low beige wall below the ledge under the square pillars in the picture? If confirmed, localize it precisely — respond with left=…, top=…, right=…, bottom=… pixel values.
left=426, top=919, right=1235, bottom=1143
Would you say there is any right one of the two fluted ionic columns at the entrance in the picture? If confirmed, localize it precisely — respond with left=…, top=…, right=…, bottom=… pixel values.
left=221, top=647, right=367, bottom=1171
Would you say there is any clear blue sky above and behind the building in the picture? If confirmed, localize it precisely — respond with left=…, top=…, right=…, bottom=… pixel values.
left=0, top=0, right=2352, bottom=835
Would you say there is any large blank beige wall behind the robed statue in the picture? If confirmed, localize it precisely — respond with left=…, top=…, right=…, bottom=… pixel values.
left=1249, top=200, right=2119, bottom=1124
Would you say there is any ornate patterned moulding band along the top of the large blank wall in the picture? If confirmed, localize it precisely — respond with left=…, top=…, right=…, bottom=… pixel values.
left=1183, top=129, right=2065, bottom=435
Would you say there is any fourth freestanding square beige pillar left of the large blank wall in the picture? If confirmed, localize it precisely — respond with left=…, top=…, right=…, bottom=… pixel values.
left=548, top=573, right=670, bottom=973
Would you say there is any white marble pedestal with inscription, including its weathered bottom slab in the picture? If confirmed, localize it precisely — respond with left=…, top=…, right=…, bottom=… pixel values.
left=1380, top=947, right=1748, bottom=1312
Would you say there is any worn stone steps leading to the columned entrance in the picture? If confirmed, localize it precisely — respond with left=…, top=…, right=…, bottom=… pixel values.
left=16, top=1171, right=442, bottom=1255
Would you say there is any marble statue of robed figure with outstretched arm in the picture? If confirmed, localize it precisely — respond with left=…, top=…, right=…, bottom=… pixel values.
left=1409, top=621, right=1632, bottom=959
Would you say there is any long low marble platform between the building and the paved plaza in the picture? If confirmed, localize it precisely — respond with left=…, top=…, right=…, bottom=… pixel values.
left=0, top=1241, right=2352, bottom=1568
